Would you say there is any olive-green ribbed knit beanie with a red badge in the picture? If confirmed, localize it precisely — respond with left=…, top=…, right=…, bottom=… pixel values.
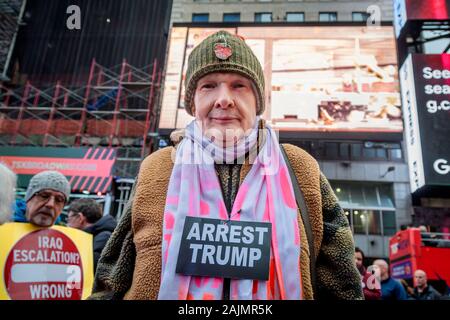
left=184, top=30, right=264, bottom=116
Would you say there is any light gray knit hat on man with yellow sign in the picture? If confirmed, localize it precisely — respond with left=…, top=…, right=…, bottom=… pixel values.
left=25, top=171, right=70, bottom=203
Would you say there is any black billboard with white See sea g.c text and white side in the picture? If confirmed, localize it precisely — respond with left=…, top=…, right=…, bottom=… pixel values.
left=400, top=54, right=450, bottom=192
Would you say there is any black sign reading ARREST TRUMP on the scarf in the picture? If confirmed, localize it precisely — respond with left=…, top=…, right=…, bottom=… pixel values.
left=176, top=217, right=272, bottom=280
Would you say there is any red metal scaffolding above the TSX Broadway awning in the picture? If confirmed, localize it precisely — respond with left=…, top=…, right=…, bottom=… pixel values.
left=0, top=59, right=161, bottom=177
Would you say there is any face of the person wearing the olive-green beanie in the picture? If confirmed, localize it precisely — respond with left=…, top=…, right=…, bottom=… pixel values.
left=194, top=72, right=256, bottom=145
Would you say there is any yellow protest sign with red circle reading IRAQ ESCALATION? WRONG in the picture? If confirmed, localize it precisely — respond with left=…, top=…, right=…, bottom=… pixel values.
left=0, top=223, right=94, bottom=300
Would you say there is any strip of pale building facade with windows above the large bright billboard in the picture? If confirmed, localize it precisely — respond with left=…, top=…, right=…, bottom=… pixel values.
left=172, top=0, right=392, bottom=23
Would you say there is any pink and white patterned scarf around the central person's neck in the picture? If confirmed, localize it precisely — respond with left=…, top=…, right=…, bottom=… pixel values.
left=158, top=119, right=302, bottom=300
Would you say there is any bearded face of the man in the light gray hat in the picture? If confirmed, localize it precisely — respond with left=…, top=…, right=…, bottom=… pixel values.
left=26, top=189, right=66, bottom=227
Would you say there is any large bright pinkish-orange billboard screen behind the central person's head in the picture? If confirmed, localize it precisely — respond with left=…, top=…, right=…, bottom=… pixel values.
left=160, top=26, right=402, bottom=133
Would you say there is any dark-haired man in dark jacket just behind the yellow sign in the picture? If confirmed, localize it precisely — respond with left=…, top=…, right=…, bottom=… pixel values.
left=67, top=199, right=117, bottom=271
